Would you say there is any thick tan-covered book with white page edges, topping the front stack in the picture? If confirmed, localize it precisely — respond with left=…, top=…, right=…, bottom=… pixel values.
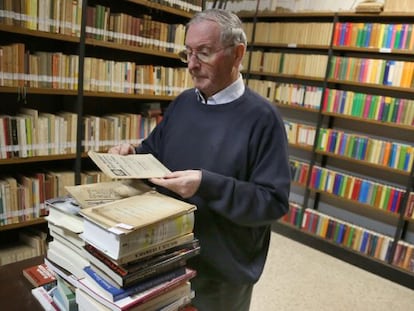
left=80, top=191, right=196, bottom=260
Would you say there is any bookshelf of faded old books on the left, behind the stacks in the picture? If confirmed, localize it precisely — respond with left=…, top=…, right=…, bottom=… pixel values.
left=0, top=0, right=203, bottom=266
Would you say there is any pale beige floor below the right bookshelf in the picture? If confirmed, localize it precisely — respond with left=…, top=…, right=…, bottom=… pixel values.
left=251, top=233, right=414, bottom=311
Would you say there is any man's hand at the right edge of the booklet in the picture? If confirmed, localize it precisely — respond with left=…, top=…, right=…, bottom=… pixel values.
left=149, top=170, right=201, bottom=199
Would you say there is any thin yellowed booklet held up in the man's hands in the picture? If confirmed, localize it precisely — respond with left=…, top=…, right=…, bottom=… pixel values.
left=88, top=151, right=170, bottom=179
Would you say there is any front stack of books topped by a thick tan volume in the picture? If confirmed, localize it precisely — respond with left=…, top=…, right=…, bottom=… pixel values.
left=77, top=190, right=200, bottom=310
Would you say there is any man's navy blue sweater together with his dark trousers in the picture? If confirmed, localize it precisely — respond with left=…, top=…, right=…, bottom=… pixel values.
left=137, top=88, right=290, bottom=283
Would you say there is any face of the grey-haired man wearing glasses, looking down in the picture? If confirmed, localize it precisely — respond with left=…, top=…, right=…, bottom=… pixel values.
left=185, top=21, right=238, bottom=97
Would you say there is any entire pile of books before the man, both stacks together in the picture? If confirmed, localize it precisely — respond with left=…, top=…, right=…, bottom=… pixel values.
left=35, top=152, right=200, bottom=310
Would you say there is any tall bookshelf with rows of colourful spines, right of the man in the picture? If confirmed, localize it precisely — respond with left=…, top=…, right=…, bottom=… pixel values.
left=239, top=11, right=414, bottom=288
